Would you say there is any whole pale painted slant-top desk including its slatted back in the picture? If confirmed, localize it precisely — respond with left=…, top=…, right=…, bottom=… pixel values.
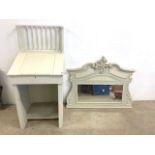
left=8, top=25, right=64, bottom=128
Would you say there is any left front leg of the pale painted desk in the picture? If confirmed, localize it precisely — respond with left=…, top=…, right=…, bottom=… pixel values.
left=13, top=86, right=27, bottom=129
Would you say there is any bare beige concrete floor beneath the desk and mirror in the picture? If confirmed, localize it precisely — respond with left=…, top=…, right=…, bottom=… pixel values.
left=0, top=101, right=155, bottom=135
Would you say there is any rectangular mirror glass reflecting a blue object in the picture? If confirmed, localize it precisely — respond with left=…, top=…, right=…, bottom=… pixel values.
left=78, top=85, right=123, bottom=102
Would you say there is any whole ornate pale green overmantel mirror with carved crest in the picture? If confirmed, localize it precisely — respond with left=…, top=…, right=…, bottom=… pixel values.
left=67, top=57, right=134, bottom=108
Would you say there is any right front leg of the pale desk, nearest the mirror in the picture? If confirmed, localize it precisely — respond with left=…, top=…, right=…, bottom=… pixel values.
left=58, top=84, right=63, bottom=128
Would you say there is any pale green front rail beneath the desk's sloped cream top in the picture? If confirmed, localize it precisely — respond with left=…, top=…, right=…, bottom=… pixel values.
left=9, top=76, right=63, bottom=85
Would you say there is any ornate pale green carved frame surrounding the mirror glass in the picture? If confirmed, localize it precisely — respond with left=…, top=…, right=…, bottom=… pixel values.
left=67, top=57, right=133, bottom=108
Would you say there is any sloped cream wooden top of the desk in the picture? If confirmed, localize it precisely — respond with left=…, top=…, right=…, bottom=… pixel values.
left=8, top=51, right=64, bottom=76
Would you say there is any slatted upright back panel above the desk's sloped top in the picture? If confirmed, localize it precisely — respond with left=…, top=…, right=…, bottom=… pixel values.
left=17, top=25, right=63, bottom=52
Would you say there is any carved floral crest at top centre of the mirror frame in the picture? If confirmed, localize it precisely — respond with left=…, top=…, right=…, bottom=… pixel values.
left=91, top=57, right=111, bottom=73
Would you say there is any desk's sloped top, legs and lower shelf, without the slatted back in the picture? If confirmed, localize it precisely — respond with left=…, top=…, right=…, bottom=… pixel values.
left=8, top=51, right=64, bottom=128
